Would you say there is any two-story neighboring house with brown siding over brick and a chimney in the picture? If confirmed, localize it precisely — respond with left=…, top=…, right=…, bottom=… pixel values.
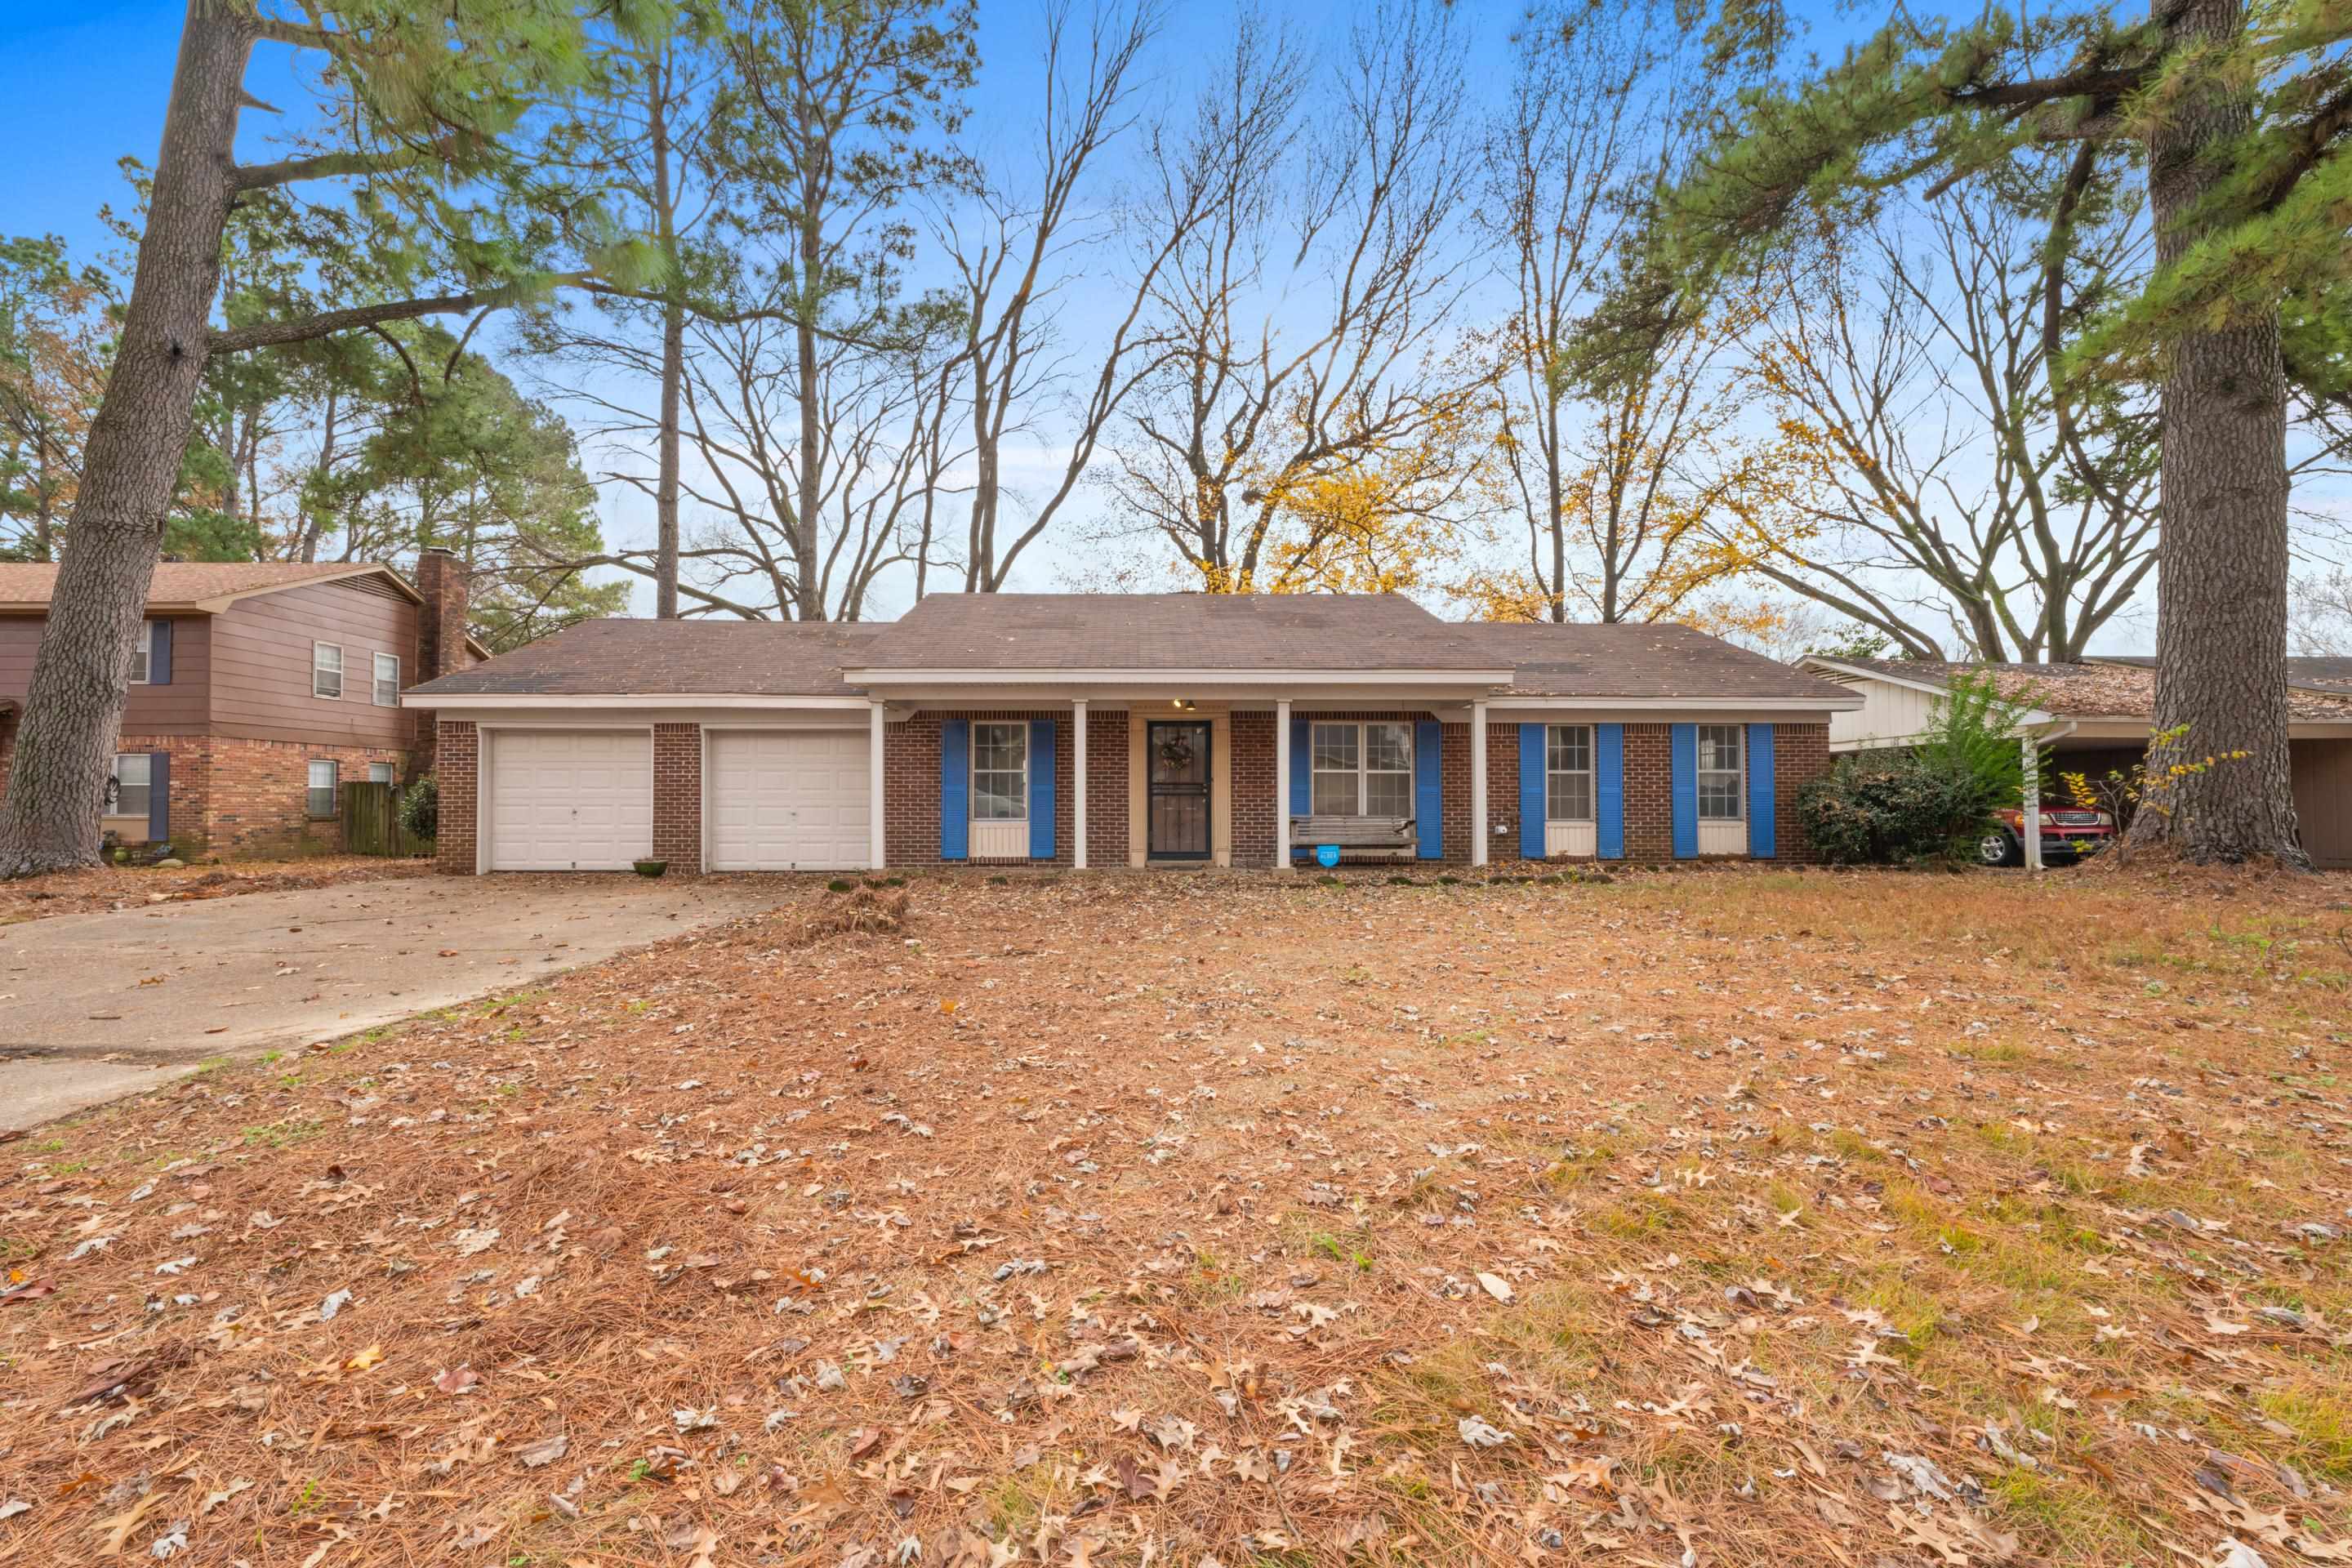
left=0, top=550, right=487, bottom=856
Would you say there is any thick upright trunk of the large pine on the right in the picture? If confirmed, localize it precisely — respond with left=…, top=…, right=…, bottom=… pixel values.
left=2131, top=0, right=2305, bottom=865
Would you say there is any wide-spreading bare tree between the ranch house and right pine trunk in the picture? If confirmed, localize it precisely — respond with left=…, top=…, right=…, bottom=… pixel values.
left=1722, top=162, right=2157, bottom=661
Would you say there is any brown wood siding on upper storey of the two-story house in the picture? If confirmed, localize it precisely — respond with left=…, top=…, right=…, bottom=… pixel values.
left=212, top=583, right=419, bottom=747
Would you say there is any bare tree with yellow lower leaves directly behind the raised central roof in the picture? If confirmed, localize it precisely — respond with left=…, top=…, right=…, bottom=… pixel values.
left=1112, top=0, right=1475, bottom=592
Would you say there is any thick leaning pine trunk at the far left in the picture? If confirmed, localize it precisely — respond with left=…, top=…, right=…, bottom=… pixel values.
left=0, top=0, right=252, bottom=877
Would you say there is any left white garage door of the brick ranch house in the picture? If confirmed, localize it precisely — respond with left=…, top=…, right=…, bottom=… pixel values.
left=489, top=728, right=654, bottom=872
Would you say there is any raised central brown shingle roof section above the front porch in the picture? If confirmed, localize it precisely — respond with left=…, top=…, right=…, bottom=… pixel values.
left=863, top=592, right=1500, bottom=670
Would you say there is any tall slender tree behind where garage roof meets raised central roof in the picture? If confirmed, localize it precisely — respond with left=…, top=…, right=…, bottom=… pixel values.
left=689, top=0, right=976, bottom=621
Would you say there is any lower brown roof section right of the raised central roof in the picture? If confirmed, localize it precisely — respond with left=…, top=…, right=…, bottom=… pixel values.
left=1459, top=623, right=1839, bottom=701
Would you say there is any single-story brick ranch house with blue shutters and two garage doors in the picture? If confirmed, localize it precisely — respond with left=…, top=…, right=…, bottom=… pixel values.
left=402, top=595, right=1858, bottom=875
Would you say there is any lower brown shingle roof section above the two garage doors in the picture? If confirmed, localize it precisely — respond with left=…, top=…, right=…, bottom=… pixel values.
left=407, top=621, right=887, bottom=696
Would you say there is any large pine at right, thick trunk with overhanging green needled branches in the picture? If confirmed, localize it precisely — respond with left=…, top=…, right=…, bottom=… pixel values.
left=1585, top=0, right=2352, bottom=865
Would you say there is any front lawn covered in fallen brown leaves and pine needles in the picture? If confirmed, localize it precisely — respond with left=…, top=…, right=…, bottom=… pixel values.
left=0, top=872, right=2352, bottom=1568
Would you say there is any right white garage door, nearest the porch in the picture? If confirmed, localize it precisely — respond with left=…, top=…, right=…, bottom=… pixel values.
left=708, top=728, right=872, bottom=872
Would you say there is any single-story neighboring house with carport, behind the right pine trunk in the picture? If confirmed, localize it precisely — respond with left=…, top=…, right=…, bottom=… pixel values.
left=1804, top=653, right=2352, bottom=867
